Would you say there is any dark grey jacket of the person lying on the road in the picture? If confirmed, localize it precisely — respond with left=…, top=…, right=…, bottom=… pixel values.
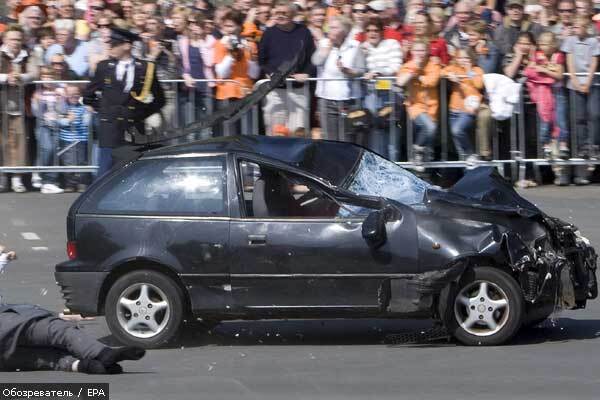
left=0, top=304, right=54, bottom=370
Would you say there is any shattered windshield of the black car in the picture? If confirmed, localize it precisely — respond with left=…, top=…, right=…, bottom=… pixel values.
left=345, top=151, right=432, bottom=205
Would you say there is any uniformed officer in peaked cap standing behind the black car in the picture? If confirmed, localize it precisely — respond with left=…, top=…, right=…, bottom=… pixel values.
left=83, top=27, right=165, bottom=176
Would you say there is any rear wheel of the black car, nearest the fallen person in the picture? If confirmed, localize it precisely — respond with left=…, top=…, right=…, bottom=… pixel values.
left=105, top=270, right=184, bottom=349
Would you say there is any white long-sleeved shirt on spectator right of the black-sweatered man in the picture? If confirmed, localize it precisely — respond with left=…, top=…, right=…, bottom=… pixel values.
left=312, top=36, right=366, bottom=101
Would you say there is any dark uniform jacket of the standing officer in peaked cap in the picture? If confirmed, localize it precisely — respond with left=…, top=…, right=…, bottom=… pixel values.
left=83, top=58, right=165, bottom=148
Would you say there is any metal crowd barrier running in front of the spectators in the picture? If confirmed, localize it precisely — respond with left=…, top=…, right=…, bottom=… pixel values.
left=0, top=74, right=600, bottom=183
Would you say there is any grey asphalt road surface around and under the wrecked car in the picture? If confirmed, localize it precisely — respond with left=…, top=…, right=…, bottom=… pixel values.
left=0, top=186, right=600, bottom=400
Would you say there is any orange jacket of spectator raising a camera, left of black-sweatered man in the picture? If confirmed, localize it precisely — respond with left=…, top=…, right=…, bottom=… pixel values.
left=214, top=40, right=257, bottom=100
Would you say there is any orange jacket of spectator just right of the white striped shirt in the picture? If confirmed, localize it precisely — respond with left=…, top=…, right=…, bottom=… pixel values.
left=398, top=60, right=441, bottom=121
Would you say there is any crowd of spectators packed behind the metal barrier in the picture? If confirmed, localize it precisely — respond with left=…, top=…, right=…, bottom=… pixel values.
left=0, top=0, right=600, bottom=193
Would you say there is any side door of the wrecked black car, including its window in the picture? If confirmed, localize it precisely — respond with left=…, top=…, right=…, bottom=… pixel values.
left=230, top=160, right=417, bottom=311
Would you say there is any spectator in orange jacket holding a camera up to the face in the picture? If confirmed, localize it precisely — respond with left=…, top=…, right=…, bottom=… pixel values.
left=214, top=10, right=260, bottom=136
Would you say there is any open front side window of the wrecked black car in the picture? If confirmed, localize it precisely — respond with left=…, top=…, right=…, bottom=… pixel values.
left=239, top=161, right=368, bottom=218
